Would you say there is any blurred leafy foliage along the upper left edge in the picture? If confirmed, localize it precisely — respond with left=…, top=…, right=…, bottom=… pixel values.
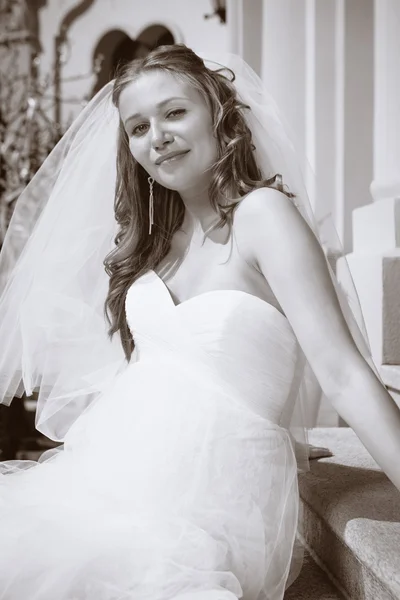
left=0, top=0, right=61, bottom=246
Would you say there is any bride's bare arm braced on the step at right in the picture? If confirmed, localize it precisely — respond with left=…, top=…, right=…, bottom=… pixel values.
left=240, top=188, right=400, bottom=490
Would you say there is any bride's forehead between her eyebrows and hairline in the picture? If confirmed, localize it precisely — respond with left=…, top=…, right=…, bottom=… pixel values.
left=119, top=70, right=205, bottom=121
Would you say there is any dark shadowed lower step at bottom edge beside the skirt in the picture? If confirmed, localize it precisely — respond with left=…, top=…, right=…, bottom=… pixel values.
left=284, top=552, right=344, bottom=600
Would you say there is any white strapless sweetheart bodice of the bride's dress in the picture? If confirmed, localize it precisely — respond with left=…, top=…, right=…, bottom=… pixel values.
left=126, top=271, right=301, bottom=424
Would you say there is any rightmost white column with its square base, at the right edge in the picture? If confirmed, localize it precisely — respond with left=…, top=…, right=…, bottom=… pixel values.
left=340, top=0, right=400, bottom=368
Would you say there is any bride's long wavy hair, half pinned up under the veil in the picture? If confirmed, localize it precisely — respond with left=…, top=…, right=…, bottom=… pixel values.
left=104, top=44, right=294, bottom=362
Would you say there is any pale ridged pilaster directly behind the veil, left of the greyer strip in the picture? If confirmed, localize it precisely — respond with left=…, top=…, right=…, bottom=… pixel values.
left=262, top=0, right=343, bottom=219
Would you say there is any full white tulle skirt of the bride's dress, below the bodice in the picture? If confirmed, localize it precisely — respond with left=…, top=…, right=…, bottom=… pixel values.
left=0, top=362, right=299, bottom=600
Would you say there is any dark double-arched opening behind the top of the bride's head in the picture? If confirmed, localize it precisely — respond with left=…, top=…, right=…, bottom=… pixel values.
left=92, top=25, right=175, bottom=96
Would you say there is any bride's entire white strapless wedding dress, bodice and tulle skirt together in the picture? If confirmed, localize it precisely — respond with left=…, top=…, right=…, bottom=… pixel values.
left=0, top=271, right=300, bottom=600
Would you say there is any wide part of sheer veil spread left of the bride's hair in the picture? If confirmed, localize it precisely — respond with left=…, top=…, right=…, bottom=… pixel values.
left=0, top=83, right=125, bottom=441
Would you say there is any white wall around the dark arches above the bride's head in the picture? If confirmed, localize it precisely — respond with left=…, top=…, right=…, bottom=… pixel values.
left=39, top=0, right=228, bottom=122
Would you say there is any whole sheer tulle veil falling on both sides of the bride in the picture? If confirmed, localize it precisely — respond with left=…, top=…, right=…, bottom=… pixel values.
left=0, top=48, right=375, bottom=469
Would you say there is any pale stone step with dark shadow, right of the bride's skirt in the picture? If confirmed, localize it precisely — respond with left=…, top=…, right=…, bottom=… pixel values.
left=300, top=427, right=400, bottom=600
